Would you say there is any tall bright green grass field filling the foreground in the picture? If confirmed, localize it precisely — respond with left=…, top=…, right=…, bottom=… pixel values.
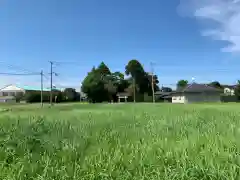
left=0, top=104, right=240, bottom=180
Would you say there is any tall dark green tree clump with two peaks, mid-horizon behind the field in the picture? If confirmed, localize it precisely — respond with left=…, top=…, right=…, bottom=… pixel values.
left=82, top=59, right=159, bottom=102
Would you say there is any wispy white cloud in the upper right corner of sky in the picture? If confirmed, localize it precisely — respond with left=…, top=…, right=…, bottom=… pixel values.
left=180, top=0, right=240, bottom=52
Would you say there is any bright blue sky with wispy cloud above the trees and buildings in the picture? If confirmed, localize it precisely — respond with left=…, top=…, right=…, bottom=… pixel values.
left=0, top=0, right=240, bottom=88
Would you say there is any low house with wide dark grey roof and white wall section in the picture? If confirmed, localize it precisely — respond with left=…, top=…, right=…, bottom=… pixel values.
left=172, top=83, right=223, bottom=103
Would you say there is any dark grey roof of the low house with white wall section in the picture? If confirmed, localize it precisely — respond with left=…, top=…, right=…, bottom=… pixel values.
left=176, top=83, right=223, bottom=93
